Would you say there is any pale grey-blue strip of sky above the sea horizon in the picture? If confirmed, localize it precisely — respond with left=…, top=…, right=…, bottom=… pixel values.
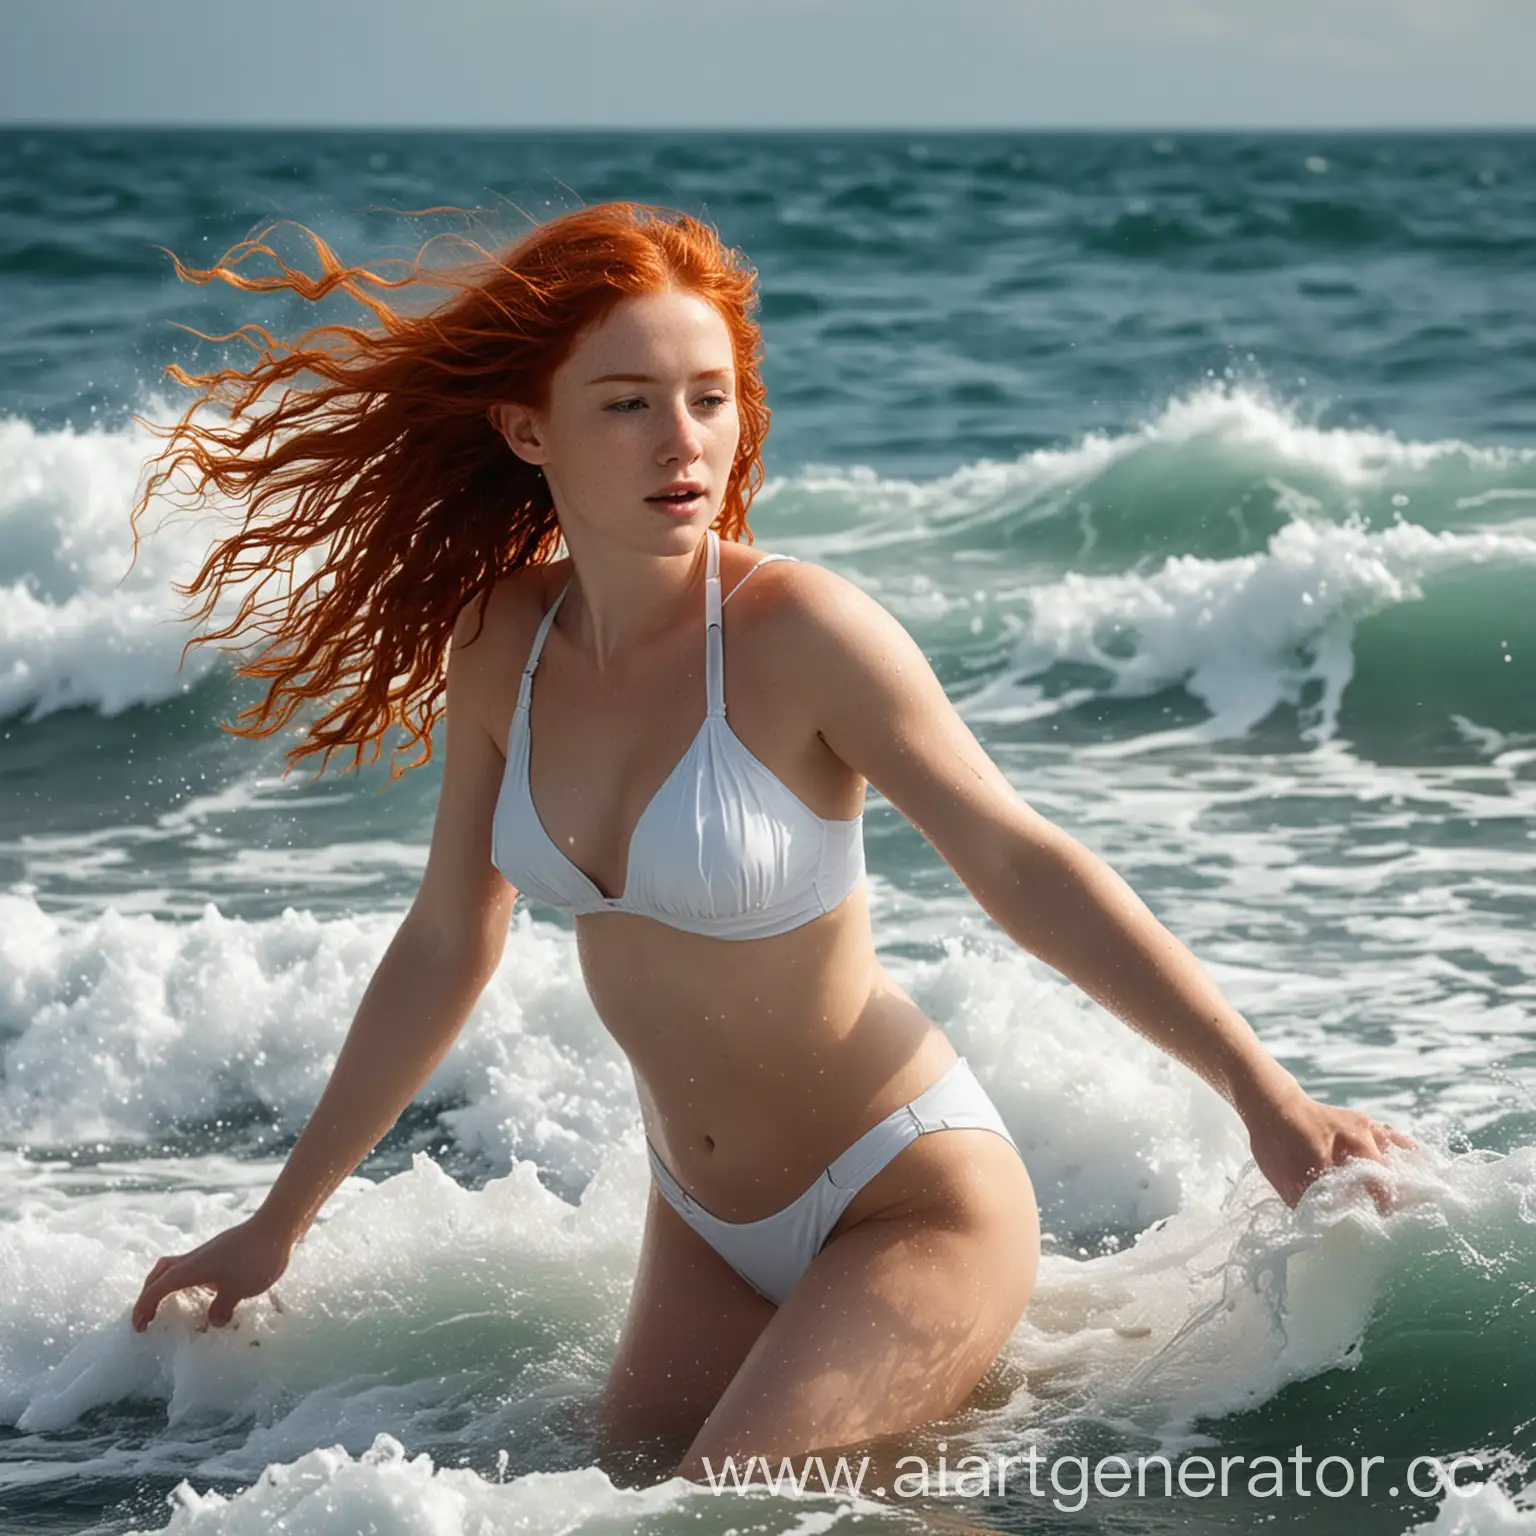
left=0, top=0, right=1536, bottom=129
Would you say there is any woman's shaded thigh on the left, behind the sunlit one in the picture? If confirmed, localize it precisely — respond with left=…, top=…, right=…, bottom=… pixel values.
left=599, top=1184, right=777, bottom=1461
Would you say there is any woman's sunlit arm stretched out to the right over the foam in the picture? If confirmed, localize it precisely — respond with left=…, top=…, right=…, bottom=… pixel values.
left=771, top=564, right=1413, bottom=1206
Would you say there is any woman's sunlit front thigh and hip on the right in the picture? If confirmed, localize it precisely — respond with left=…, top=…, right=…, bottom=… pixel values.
left=677, top=1129, right=1040, bottom=1478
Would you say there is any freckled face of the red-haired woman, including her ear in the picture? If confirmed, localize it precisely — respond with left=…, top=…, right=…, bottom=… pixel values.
left=496, top=290, right=742, bottom=554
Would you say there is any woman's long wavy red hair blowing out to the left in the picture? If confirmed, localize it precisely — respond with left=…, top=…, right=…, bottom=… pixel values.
left=129, top=203, right=768, bottom=779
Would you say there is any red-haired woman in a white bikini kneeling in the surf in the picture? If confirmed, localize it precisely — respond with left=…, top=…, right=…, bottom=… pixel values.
left=134, top=204, right=1404, bottom=1478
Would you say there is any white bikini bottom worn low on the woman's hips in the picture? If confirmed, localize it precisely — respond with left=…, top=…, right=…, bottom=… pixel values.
left=645, top=1057, right=1023, bottom=1304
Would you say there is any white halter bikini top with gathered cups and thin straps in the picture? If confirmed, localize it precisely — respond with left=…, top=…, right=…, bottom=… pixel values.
left=492, top=528, right=865, bottom=938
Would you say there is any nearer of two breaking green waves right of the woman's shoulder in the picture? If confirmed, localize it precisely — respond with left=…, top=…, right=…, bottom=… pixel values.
left=968, top=521, right=1536, bottom=750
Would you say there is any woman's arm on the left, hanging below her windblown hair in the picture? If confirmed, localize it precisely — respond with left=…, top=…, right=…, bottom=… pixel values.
left=134, top=599, right=518, bottom=1332
